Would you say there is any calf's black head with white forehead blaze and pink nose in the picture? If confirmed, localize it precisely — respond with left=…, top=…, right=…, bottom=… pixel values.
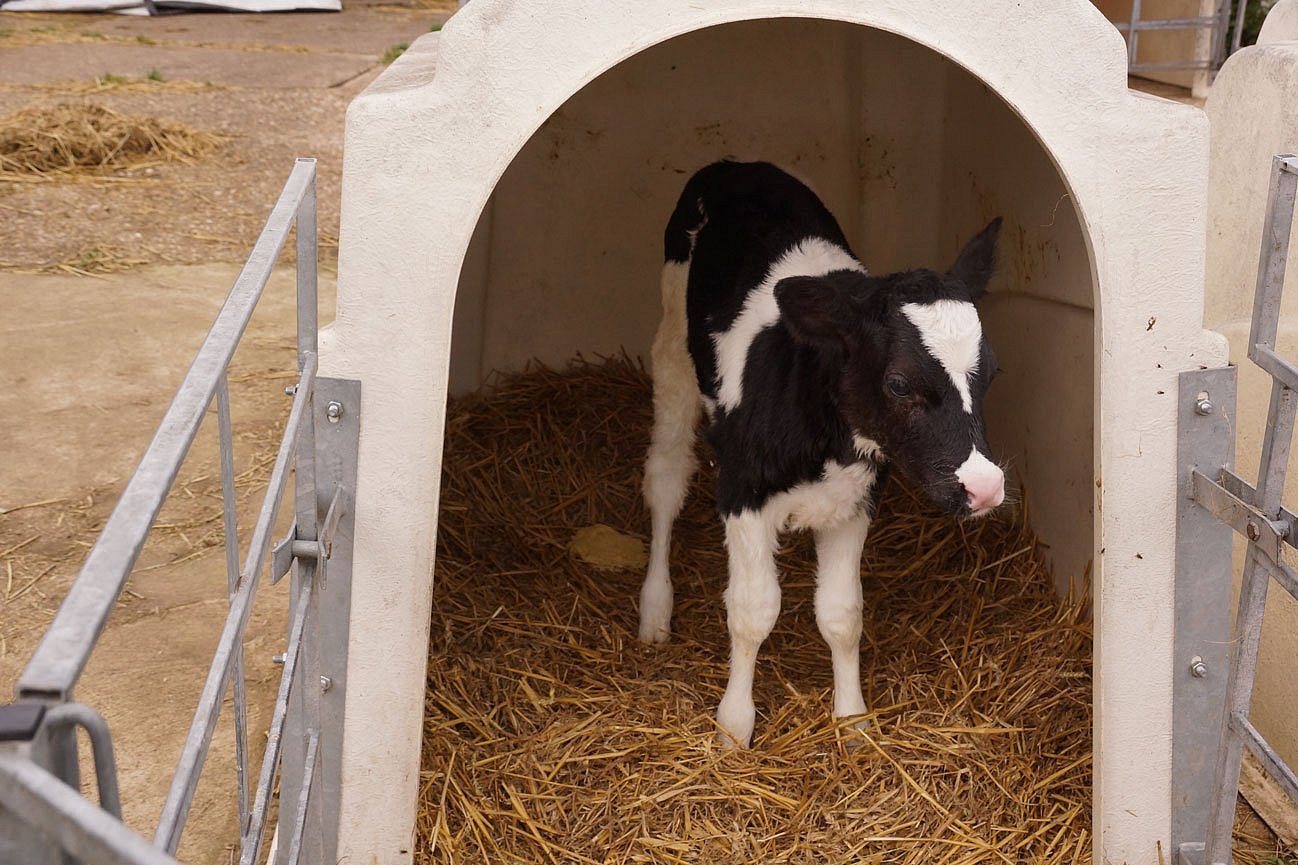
left=775, top=218, right=1005, bottom=516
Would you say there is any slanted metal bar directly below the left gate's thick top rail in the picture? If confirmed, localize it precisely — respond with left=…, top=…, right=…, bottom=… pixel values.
left=153, top=355, right=315, bottom=853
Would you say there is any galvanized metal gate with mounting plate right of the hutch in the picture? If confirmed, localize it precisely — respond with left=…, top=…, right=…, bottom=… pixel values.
left=1172, top=155, right=1298, bottom=865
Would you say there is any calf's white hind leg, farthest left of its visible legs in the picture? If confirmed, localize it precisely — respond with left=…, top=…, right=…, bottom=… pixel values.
left=640, top=261, right=700, bottom=643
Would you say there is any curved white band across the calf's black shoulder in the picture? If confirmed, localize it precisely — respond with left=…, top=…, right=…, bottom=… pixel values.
left=713, top=238, right=866, bottom=412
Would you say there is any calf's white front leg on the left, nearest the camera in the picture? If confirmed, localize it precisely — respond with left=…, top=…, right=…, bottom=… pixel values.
left=716, top=510, right=780, bottom=748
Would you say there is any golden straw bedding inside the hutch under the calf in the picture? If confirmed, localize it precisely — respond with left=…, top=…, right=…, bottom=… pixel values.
left=417, top=360, right=1090, bottom=865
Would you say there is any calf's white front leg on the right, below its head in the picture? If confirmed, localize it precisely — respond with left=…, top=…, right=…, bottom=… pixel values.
left=815, top=512, right=870, bottom=718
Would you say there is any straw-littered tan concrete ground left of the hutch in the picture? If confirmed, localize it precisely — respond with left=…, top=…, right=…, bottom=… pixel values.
left=0, top=1, right=454, bottom=864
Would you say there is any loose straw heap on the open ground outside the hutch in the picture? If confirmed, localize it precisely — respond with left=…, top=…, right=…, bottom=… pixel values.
left=0, top=103, right=222, bottom=177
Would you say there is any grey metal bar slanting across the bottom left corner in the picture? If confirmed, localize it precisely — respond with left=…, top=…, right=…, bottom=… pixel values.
left=0, top=753, right=179, bottom=865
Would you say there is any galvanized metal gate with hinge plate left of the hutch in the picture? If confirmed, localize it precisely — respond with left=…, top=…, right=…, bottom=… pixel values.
left=0, top=160, right=360, bottom=865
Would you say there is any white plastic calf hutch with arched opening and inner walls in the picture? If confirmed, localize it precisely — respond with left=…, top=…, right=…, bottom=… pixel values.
left=322, top=0, right=1227, bottom=865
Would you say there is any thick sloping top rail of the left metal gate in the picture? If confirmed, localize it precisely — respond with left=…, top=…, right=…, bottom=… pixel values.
left=18, top=161, right=315, bottom=700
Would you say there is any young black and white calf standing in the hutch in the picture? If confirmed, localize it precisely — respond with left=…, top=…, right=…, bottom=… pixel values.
left=640, top=162, right=1005, bottom=746
